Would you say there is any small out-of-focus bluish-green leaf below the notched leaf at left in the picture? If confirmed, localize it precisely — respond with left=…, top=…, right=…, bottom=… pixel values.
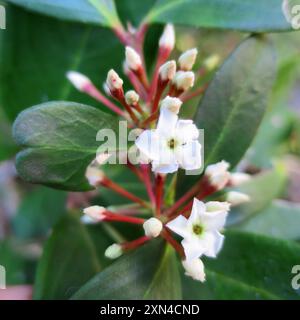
left=12, top=187, right=66, bottom=239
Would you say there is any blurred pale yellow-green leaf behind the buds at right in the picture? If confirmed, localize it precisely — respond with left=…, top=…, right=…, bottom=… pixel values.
left=227, top=162, right=287, bottom=225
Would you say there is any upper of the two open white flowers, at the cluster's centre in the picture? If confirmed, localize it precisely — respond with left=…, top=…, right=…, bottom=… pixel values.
left=135, top=100, right=201, bottom=174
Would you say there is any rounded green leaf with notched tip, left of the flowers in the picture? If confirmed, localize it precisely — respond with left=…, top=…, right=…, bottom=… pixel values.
left=13, top=102, right=117, bottom=191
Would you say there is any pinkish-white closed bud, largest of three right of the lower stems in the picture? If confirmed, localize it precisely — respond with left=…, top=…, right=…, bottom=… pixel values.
left=205, top=160, right=230, bottom=190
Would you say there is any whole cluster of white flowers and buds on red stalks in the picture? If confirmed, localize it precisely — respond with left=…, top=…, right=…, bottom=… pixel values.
left=67, top=24, right=249, bottom=281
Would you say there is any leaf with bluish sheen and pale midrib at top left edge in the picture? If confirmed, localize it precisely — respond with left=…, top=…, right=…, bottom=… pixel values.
left=6, top=0, right=119, bottom=26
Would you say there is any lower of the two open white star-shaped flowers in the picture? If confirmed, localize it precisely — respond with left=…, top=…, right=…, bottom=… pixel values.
left=167, top=198, right=228, bottom=260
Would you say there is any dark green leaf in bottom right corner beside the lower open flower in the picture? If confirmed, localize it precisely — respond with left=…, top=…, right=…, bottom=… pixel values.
left=183, top=231, right=300, bottom=299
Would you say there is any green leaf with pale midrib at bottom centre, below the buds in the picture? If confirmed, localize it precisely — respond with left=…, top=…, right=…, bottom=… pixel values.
left=72, top=240, right=181, bottom=300
